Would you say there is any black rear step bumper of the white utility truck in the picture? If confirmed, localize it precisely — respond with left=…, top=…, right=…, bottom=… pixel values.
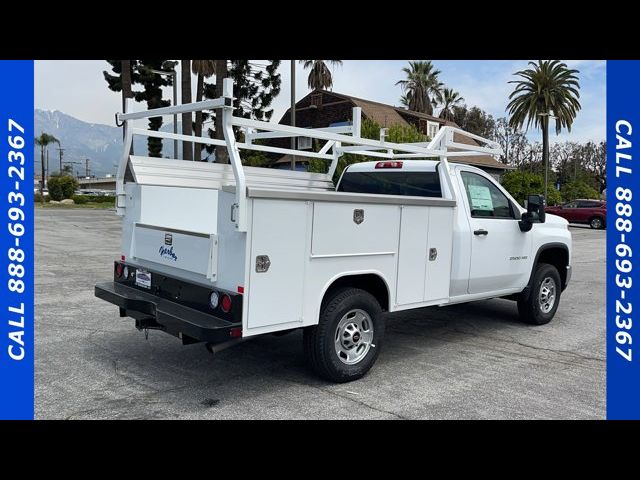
left=95, top=282, right=242, bottom=344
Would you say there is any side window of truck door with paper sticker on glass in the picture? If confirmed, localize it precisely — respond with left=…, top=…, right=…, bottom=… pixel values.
left=461, top=172, right=514, bottom=218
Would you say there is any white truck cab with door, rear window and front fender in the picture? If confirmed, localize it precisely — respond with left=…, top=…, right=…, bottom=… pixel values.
left=336, top=160, right=571, bottom=308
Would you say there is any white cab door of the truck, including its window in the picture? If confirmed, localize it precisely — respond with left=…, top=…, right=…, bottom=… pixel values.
left=459, top=169, right=532, bottom=293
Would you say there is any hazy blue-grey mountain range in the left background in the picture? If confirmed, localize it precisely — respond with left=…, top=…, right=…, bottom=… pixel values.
left=34, top=108, right=180, bottom=177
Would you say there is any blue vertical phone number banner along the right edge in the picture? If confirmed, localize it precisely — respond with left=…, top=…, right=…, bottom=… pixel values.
left=607, top=60, right=640, bottom=420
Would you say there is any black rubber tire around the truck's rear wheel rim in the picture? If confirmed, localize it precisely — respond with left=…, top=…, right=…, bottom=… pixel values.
left=303, top=288, right=384, bottom=383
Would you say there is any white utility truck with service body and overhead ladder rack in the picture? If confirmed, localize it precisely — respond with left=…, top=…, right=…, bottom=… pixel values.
left=95, top=79, right=571, bottom=382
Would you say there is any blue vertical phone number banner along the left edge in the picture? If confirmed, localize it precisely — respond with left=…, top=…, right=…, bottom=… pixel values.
left=0, top=60, right=34, bottom=419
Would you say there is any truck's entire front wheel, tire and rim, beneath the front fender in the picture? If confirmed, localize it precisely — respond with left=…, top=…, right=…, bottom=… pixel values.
left=518, top=263, right=562, bottom=325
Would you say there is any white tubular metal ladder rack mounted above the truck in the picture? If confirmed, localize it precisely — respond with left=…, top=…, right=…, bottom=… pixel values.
left=116, top=78, right=502, bottom=232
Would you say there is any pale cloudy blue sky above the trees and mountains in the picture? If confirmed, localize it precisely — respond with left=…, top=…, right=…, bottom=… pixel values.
left=35, top=60, right=606, bottom=142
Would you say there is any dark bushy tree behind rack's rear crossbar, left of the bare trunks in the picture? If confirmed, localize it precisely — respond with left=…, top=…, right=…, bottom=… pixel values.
left=133, top=60, right=177, bottom=157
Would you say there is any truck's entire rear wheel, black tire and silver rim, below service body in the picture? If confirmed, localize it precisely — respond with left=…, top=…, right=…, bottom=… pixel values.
left=303, top=288, right=384, bottom=383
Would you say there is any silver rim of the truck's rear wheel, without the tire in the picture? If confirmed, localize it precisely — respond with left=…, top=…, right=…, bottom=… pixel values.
left=334, top=309, right=374, bottom=365
